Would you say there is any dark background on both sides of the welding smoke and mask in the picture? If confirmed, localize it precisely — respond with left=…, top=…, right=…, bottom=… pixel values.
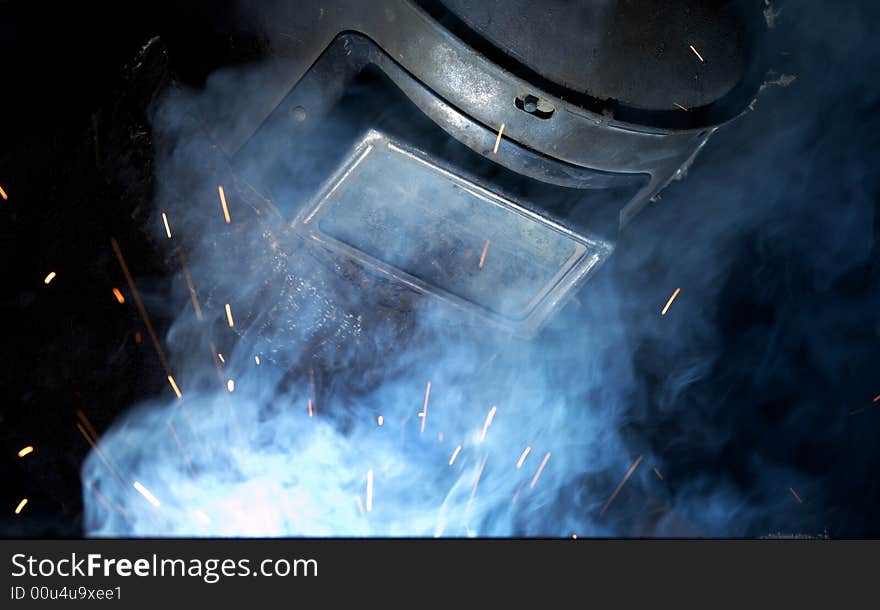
left=0, top=2, right=880, bottom=537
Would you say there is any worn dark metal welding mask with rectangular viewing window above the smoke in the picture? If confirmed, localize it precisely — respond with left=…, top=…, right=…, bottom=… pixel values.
left=205, top=0, right=766, bottom=334
